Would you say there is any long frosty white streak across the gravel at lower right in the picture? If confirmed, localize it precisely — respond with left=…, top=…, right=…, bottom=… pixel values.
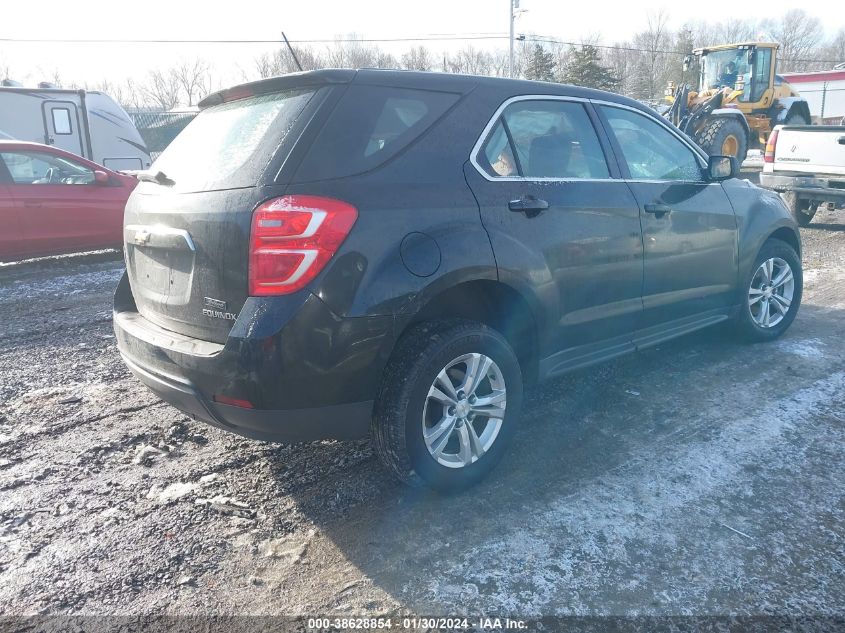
left=429, top=372, right=845, bottom=616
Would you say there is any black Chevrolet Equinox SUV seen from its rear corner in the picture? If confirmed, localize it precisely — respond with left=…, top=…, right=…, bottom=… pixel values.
left=114, top=70, right=802, bottom=489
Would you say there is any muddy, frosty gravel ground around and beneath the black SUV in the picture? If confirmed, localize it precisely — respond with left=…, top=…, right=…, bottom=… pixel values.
left=0, top=212, right=845, bottom=616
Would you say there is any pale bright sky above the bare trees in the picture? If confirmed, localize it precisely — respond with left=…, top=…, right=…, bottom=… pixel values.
left=0, top=0, right=845, bottom=85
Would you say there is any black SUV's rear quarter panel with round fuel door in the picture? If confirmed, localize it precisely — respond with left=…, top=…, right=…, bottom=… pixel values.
left=286, top=79, right=504, bottom=320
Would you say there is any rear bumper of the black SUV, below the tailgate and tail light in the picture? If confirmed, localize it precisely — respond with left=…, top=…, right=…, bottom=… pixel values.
left=114, top=276, right=392, bottom=443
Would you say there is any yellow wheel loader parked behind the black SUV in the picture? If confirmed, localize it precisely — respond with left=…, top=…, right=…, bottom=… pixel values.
left=666, top=42, right=810, bottom=163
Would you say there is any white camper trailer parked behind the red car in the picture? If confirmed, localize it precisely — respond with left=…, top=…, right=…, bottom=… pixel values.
left=0, top=87, right=152, bottom=170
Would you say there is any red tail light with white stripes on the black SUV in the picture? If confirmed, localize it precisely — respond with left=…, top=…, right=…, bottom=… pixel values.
left=249, top=196, right=358, bottom=297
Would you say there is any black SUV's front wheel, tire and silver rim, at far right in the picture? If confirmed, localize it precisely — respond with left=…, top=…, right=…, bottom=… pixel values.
left=737, top=239, right=804, bottom=341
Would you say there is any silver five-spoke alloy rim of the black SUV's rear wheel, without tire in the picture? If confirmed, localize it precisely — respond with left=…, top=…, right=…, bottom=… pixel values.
left=422, top=353, right=507, bottom=468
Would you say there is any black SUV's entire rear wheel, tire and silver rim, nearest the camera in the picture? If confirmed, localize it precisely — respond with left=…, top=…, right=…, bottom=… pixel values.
left=371, top=321, right=522, bottom=492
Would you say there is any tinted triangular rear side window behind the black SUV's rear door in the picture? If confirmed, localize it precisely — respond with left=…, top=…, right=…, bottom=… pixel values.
left=297, top=85, right=459, bottom=181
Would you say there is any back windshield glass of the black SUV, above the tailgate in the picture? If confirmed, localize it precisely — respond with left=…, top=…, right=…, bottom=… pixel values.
left=151, top=89, right=314, bottom=191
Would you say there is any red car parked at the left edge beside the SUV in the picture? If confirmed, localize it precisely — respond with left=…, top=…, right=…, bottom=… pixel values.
left=0, top=141, right=138, bottom=261
